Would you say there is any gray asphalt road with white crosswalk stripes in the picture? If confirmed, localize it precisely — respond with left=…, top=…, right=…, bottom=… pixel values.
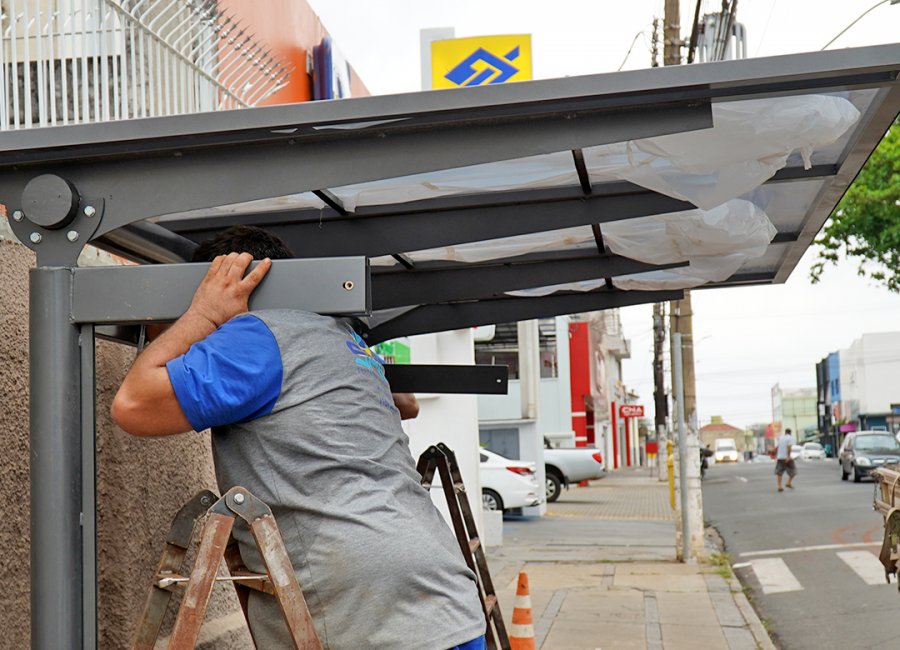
left=703, top=459, right=900, bottom=650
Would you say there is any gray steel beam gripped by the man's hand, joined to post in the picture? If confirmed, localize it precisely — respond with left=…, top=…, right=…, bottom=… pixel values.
left=71, top=257, right=371, bottom=324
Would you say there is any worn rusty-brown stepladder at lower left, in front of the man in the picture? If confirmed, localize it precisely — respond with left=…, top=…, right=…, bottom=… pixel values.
left=132, top=487, right=322, bottom=650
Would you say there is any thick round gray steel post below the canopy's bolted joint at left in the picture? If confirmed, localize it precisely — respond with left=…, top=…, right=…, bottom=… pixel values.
left=29, top=267, right=84, bottom=650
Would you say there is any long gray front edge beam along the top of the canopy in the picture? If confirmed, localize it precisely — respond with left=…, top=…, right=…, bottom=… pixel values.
left=0, top=44, right=900, bottom=165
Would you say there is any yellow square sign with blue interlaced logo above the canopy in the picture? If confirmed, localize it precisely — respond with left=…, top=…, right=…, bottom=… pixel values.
left=431, top=34, right=531, bottom=88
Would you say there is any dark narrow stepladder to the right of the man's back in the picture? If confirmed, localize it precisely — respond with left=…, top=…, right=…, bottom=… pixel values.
left=416, top=443, right=510, bottom=650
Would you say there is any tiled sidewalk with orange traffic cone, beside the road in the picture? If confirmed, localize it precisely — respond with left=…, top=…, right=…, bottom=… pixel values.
left=487, top=469, right=774, bottom=650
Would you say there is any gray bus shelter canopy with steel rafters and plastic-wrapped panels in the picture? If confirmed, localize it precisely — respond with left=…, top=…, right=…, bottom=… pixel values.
left=0, top=45, right=900, bottom=342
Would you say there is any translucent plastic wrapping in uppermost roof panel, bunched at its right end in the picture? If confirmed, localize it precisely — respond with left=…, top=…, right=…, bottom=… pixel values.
left=332, top=95, right=860, bottom=209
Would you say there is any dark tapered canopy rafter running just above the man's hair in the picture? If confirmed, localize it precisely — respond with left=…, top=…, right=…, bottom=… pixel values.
left=161, top=165, right=837, bottom=264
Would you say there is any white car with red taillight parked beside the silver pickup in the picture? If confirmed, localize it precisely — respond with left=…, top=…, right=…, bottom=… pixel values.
left=479, top=449, right=544, bottom=510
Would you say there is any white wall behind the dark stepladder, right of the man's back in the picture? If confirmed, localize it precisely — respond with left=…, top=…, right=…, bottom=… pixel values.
left=404, top=329, right=483, bottom=531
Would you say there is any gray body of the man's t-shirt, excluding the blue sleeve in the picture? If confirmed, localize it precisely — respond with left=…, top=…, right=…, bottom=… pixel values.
left=212, top=310, right=485, bottom=650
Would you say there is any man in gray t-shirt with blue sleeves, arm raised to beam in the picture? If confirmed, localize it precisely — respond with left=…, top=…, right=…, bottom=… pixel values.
left=112, top=231, right=485, bottom=650
